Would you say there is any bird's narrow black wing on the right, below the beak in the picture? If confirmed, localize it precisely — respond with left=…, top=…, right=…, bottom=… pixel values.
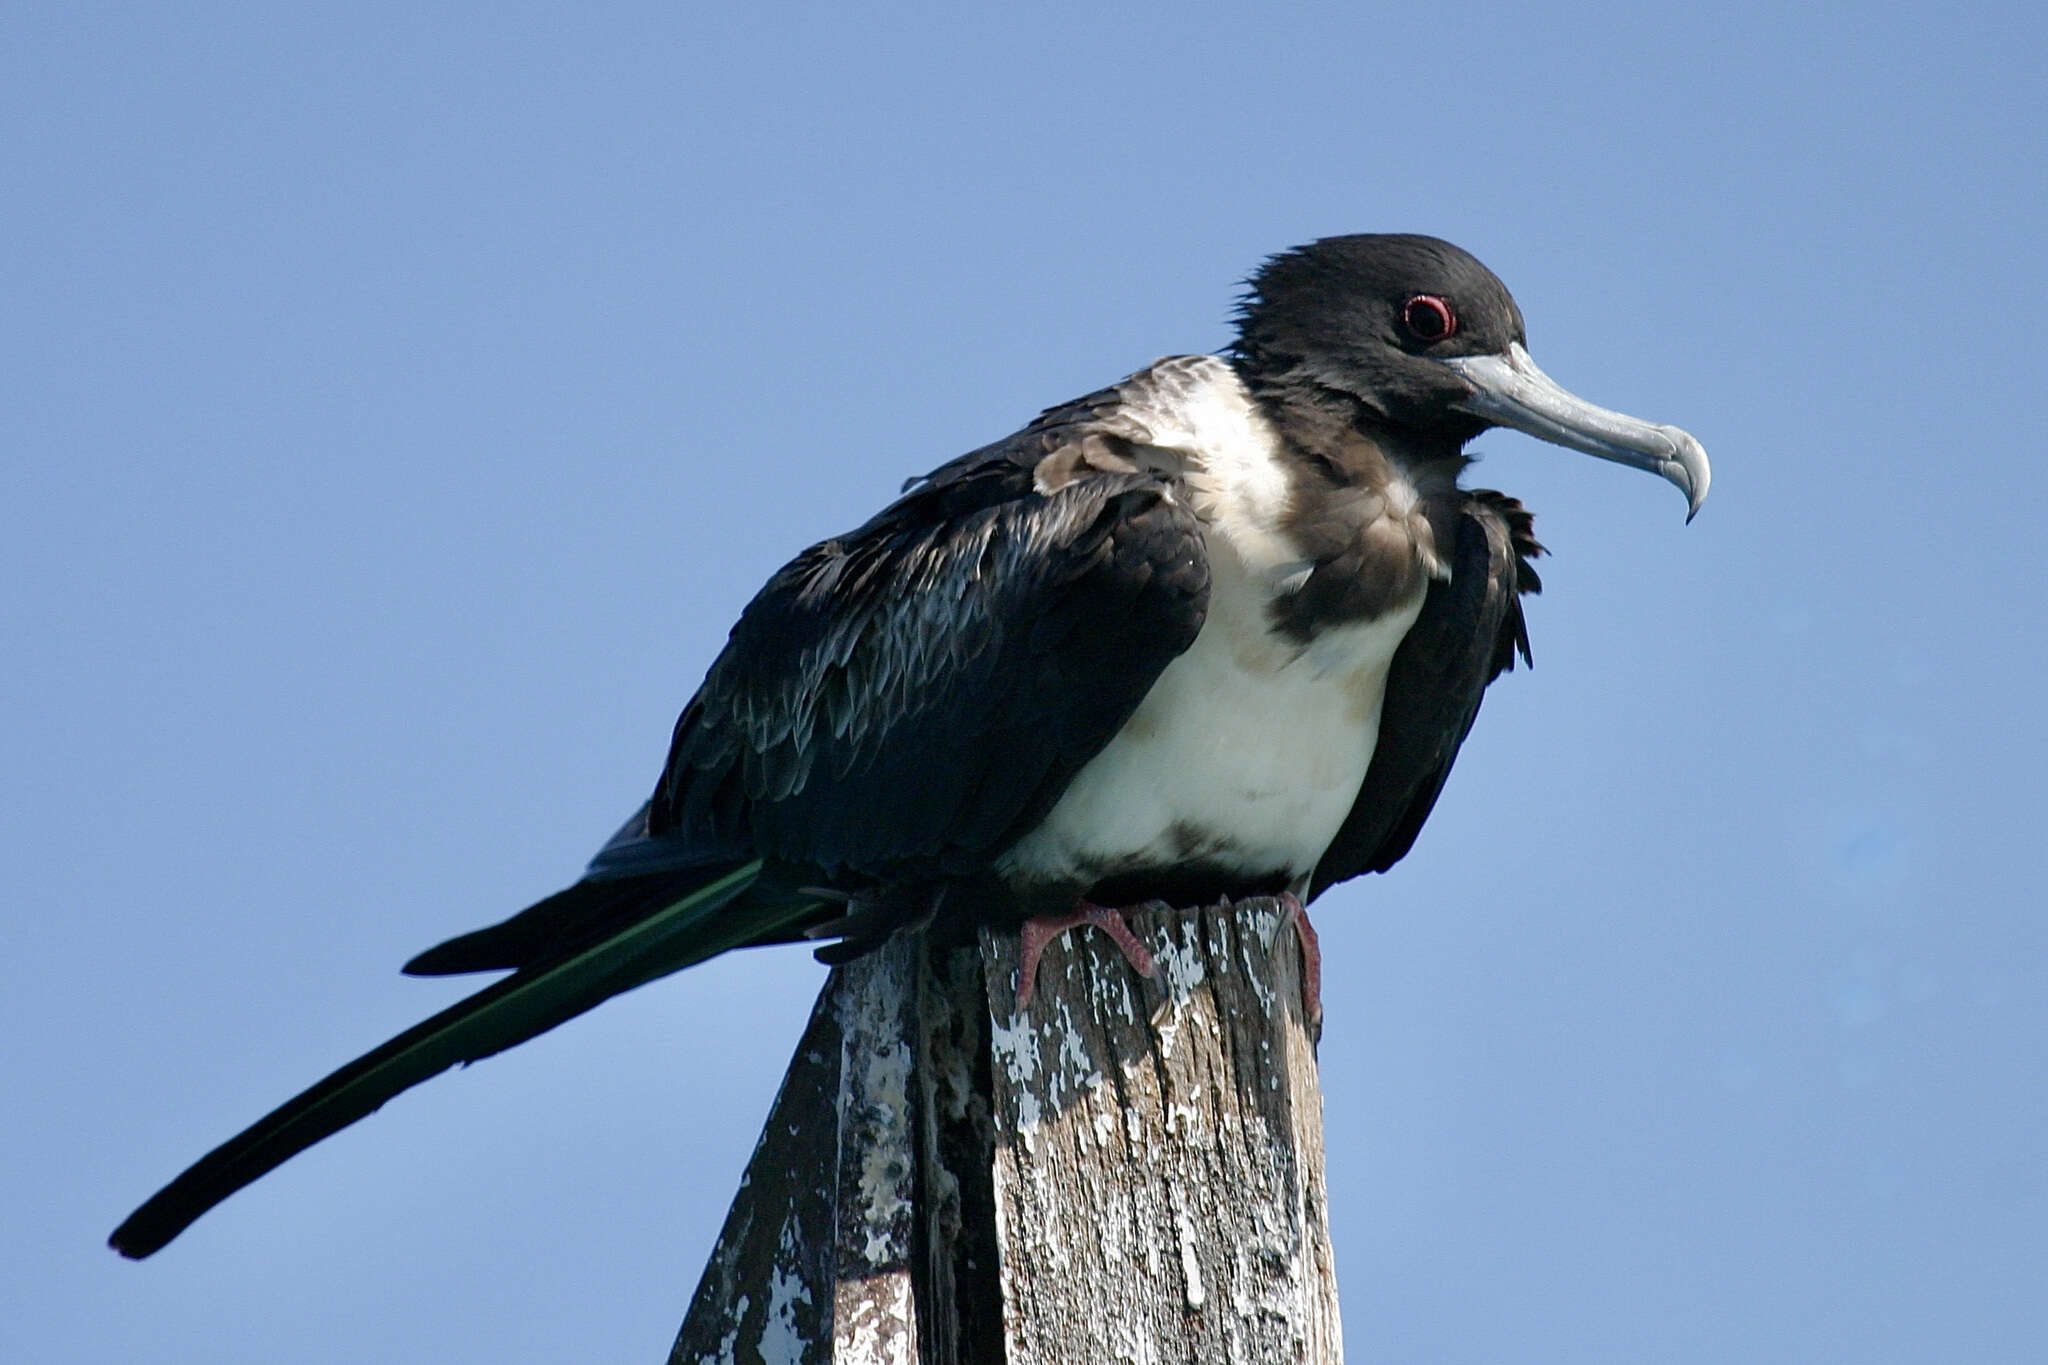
left=1309, top=491, right=1542, bottom=896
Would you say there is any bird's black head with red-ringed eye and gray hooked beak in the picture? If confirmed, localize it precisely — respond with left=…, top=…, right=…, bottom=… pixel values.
left=1237, top=233, right=1710, bottom=518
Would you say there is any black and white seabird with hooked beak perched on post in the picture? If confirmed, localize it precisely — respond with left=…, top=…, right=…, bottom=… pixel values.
left=111, top=233, right=1710, bottom=1259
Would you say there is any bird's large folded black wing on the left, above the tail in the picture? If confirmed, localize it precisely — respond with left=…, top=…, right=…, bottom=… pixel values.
left=649, top=393, right=1208, bottom=882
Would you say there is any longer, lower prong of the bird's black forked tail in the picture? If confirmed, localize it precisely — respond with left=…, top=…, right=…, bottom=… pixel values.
left=109, top=860, right=819, bottom=1259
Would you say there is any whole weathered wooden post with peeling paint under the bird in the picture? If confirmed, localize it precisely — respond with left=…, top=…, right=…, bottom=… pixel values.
left=670, top=900, right=1341, bottom=1365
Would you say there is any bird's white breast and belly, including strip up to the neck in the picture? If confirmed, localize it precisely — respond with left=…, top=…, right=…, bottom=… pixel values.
left=997, top=362, right=1421, bottom=896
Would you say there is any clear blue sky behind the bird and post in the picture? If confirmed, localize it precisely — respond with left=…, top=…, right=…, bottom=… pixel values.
left=0, top=4, right=2048, bottom=1365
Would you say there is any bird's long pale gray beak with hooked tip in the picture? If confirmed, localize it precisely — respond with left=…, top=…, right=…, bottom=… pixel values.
left=1442, top=342, right=1712, bottom=522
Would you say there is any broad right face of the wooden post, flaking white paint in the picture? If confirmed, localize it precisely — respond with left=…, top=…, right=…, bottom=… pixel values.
left=983, top=900, right=1343, bottom=1365
